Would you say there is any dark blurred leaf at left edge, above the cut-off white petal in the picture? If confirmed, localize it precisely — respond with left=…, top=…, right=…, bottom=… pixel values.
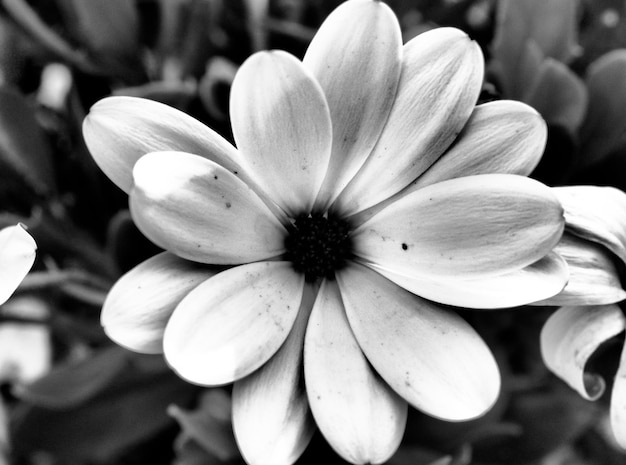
left=0, top=87, right=56, bottom=195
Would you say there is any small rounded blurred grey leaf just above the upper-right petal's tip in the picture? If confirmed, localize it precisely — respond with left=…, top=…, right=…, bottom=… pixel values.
left=524, top=58, right=588, bottom=134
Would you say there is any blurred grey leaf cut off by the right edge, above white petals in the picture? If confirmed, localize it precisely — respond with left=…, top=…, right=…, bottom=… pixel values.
left=580, top=49, right=626, bottom=168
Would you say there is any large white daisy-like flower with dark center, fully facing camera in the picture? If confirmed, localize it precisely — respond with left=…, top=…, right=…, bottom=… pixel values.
left=83, top=0, right=568, bottom=464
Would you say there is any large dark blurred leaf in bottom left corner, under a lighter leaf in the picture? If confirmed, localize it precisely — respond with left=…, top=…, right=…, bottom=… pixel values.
left=10, top=355, right=198, bottom=463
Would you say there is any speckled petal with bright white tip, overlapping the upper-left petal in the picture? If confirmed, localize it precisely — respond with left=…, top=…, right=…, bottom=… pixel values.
left=130, top=152, right=286, bottom=264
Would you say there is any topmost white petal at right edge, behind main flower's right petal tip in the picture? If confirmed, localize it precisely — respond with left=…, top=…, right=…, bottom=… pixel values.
left=553, top=186, right=626, bottom=263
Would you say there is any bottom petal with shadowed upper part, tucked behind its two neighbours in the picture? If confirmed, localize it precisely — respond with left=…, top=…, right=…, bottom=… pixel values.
left=233, top=286, right=316, bottom=465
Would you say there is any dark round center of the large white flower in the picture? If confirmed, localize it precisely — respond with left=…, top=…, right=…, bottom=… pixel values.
left=285, top=214, right=352, bottom=282
